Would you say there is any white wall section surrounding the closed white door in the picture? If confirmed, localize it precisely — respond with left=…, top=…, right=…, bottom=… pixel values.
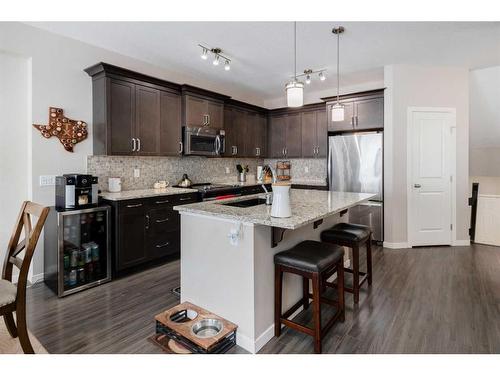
left=384, top=65, right=470, bottom=246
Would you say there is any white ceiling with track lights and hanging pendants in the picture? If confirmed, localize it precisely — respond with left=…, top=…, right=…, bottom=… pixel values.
left=30, top=21, right=500, bottom=100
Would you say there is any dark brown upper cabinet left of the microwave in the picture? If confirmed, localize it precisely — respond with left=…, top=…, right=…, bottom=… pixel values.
left=85, top=63, right=181, bottom=156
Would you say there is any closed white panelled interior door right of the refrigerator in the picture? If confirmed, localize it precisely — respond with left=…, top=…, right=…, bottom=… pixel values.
left=408, top=108, right=455, bottom=246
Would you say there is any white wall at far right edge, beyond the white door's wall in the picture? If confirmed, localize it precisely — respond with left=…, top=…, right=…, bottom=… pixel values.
left=469, top=66, right=500, bottom=177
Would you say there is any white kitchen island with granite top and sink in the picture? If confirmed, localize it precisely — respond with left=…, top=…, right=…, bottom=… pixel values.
left=174, top=189, right=374, bottom=353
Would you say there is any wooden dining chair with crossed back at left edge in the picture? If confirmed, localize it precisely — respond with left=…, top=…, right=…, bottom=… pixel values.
left=0, top=201, right=50, bottom=354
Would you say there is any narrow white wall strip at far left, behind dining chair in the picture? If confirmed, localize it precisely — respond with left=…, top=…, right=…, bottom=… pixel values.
left=0, top=51, right=31, bottom=276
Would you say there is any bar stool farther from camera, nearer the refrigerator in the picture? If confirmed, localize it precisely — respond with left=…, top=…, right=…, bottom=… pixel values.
left=321, top=223, right=372, bottom=303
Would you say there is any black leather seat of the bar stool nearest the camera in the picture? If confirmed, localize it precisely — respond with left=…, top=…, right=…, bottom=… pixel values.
left=274, top=241, right=344, bottom=272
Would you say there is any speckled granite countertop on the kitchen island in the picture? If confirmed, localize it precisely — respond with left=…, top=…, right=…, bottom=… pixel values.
left=174, top=189, right=375, bottom=229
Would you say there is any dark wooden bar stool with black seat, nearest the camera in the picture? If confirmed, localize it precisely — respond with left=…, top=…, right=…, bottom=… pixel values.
left=274, top=241, right=345, bottom=353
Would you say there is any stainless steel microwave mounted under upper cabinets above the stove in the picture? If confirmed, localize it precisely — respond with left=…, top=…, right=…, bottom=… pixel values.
left=182, top=126, right=226, bottom=156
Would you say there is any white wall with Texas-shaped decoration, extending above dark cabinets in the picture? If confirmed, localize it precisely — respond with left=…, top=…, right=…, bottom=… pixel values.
left=0, top=22, right=270, bottom=276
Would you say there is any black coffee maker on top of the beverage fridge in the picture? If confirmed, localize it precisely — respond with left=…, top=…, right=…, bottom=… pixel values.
left=56, top=174, right=99, bottom=210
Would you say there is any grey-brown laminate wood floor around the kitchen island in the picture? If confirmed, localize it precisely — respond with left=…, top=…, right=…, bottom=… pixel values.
left=28, top=245, right=500, bottom=353
